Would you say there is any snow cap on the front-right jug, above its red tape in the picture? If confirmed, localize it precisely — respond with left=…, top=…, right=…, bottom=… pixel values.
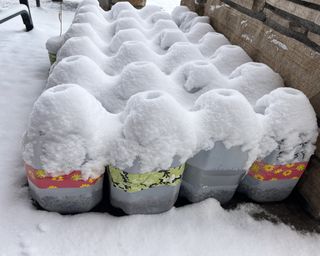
left=255, top=88, right=318, bottom=164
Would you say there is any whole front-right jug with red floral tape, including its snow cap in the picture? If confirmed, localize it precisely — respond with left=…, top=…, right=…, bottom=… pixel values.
left=239, top=88, right=318, bottom=202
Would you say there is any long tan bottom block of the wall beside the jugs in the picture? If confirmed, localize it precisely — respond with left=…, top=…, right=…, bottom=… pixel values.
left=205, top=0, right=320, bottom=117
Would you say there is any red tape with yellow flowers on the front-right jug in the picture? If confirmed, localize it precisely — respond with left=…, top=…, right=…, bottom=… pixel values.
left=248, top=161, right=308, bottom=181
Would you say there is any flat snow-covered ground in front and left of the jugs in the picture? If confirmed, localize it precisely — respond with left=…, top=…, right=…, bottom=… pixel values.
left=0, top=0, right=320, bottom=256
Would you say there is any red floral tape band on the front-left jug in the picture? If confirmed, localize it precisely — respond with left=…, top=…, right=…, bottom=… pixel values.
left=25, top=165, right=102, bottom=189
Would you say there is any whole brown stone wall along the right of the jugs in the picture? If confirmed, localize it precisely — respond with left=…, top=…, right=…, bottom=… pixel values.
left=181, top=0, right=320, bottom=218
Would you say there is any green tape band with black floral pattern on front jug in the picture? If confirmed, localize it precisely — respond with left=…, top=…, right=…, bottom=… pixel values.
left=109, top=164, right=185, bottom=193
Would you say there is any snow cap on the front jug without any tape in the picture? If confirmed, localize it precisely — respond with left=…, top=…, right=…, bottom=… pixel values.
left=195, top=89, right=262, bottom=169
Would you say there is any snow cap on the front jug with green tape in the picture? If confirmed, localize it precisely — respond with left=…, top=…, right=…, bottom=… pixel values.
left=110, top=91, right=197, bottom=172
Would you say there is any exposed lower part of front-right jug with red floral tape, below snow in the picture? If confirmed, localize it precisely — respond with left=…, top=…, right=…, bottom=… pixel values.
left=239, top=144, right=309, bottom=202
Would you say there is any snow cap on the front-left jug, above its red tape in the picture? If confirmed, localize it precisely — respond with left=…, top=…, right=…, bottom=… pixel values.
left=24, top=85, right=121, bottom=177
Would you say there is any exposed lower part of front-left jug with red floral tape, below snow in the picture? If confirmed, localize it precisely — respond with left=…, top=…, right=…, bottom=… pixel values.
left=26, top=165, right=103, bottom=214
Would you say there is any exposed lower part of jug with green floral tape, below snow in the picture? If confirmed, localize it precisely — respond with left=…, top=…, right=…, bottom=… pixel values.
left=108, top=162, right=184, bottom=214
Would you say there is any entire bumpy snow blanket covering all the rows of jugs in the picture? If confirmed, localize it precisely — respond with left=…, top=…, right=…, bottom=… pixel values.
left=24, top=0, right=317, bottom=177
